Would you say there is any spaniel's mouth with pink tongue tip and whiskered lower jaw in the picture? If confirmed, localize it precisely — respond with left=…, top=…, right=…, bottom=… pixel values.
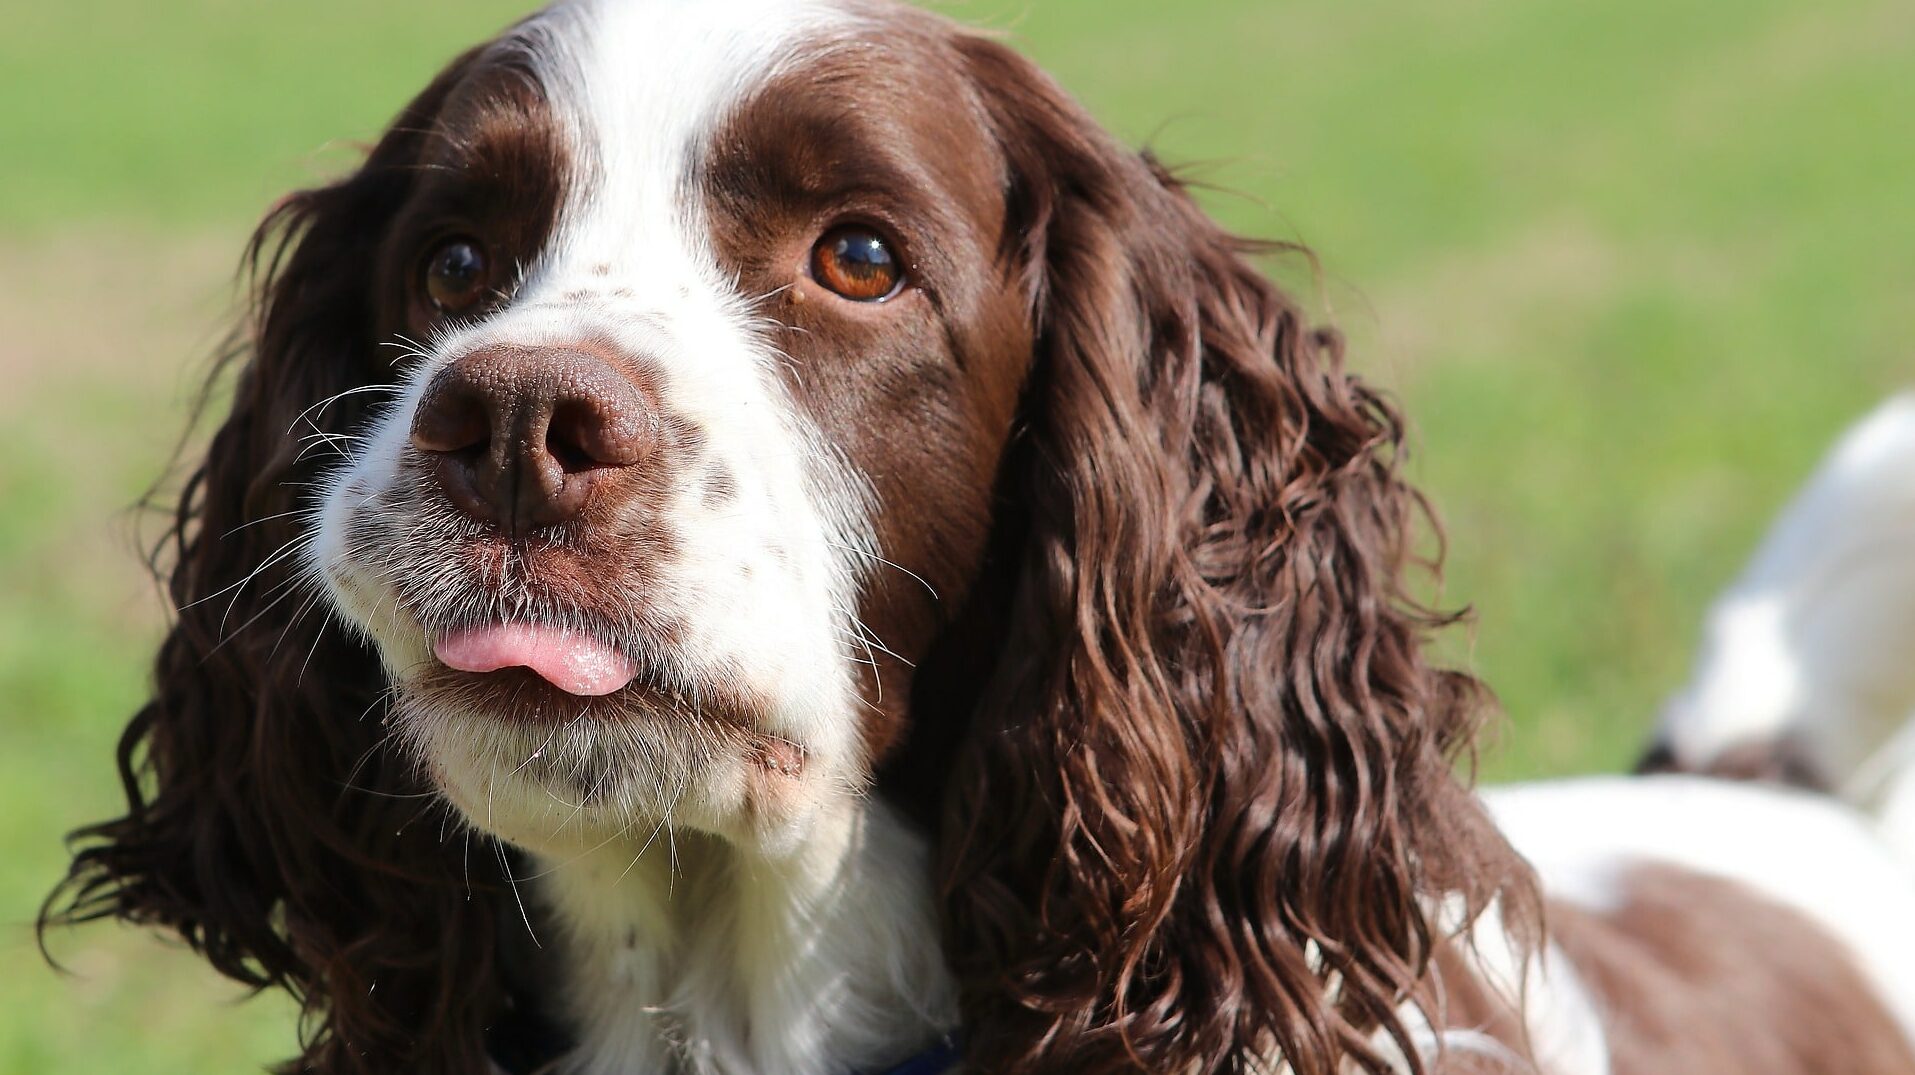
left=394, top=619, right=814, bottom=845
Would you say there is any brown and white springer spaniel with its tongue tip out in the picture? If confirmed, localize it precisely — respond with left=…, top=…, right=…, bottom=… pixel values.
left=48, top=0, right=1915, bottom=1075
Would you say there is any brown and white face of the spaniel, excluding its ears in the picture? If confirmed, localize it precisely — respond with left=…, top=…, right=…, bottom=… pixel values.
left=306, top=4, right=1034, bottom=849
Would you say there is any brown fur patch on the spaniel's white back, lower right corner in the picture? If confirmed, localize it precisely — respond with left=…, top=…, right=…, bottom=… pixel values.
left=1549, top=866, right=1915, bottom=1075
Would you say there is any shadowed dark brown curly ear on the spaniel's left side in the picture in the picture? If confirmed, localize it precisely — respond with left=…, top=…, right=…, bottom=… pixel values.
left=42, top=45, right=520, bottom=1073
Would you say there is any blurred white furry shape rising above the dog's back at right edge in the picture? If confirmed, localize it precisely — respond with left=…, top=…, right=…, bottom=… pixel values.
left=1643, top=393, right=1915, bottom=847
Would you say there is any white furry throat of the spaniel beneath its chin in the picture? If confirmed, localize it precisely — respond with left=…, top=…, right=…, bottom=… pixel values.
left=540, top=799, right=958, bottom=1075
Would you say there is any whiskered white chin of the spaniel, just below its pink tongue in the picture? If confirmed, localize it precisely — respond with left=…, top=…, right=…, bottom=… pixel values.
left=394, top=667, right=829, bottom=855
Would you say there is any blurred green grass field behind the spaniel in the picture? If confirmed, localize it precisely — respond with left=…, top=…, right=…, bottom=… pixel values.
left=0, top=0, right=1915, bottom=1073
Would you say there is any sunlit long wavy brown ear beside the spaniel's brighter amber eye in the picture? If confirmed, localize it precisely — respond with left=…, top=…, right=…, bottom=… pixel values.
left=940, top=40, right=1526, bottom=1075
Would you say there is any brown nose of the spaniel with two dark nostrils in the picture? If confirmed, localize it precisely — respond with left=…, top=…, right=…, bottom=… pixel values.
left=412, top=347, right=653, bottom=537
